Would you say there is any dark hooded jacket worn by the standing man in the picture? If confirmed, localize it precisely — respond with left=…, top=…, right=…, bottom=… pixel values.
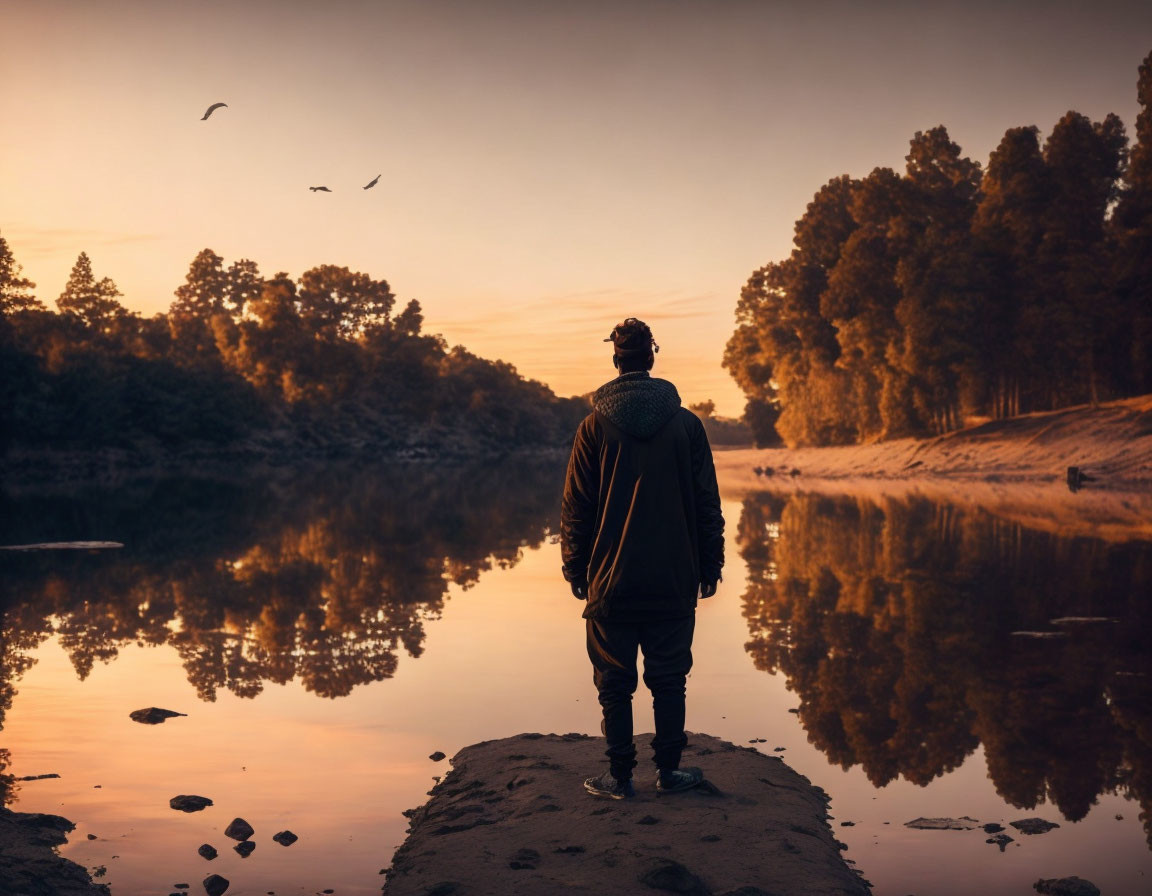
left=560, top=372, right=723, bottom=620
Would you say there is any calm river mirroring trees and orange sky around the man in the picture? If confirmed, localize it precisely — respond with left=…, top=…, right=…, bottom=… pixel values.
left=0, top=463, right=1152, bottom=896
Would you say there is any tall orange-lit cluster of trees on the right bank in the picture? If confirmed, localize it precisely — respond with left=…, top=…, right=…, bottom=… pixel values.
left=723, top=47, right=1152, bottom=446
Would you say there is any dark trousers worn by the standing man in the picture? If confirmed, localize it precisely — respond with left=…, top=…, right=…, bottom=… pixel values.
left=588, top=615, right=696, bottom=779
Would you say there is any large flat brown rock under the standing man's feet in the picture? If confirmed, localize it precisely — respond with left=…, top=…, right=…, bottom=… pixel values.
left=384, top=735, right=869, bottom=896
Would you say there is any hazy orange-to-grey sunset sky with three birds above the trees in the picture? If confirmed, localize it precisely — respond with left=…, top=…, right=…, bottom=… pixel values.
left=0, top=0, right=1152, bottom=415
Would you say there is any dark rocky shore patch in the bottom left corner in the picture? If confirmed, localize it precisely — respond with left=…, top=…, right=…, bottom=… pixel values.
left=0, top=808, right=108, bottom=896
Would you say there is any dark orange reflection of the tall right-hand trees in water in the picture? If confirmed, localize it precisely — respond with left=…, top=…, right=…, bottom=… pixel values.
left=738, top=494, right=1152, bottom=845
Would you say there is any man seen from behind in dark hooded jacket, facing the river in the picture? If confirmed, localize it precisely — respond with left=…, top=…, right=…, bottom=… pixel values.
left=561, top=318, right=723, bottom=799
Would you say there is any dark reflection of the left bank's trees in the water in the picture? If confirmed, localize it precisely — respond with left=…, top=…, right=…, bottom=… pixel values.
left=0, top=463, right=563, bottom=764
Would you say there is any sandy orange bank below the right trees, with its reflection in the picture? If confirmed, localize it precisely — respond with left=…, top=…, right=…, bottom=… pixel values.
left=714, top=395, right=1152, bottom=540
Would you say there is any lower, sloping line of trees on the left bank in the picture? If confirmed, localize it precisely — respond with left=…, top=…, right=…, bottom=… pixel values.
left=0, top=236, right=586, bottom=465
